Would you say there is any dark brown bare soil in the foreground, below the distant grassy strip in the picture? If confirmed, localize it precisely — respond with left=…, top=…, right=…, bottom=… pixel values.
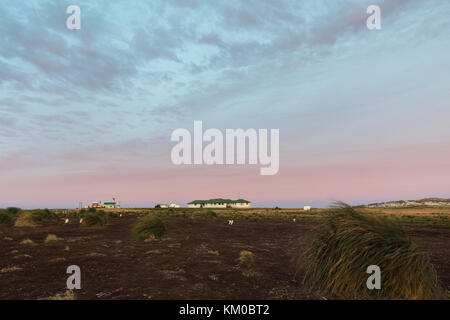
left=0, top=217, right=450, bottom=299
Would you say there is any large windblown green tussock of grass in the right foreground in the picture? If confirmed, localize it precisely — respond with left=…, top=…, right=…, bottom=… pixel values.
left=299, top=204, right=446, bottom=299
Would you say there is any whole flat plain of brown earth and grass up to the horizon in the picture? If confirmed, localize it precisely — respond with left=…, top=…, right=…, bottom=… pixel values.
left=0, top=207, right=450, bottom=299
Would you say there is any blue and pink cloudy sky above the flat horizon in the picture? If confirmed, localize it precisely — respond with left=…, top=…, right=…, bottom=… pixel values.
left=0, top=0, right=450, bottom=208
